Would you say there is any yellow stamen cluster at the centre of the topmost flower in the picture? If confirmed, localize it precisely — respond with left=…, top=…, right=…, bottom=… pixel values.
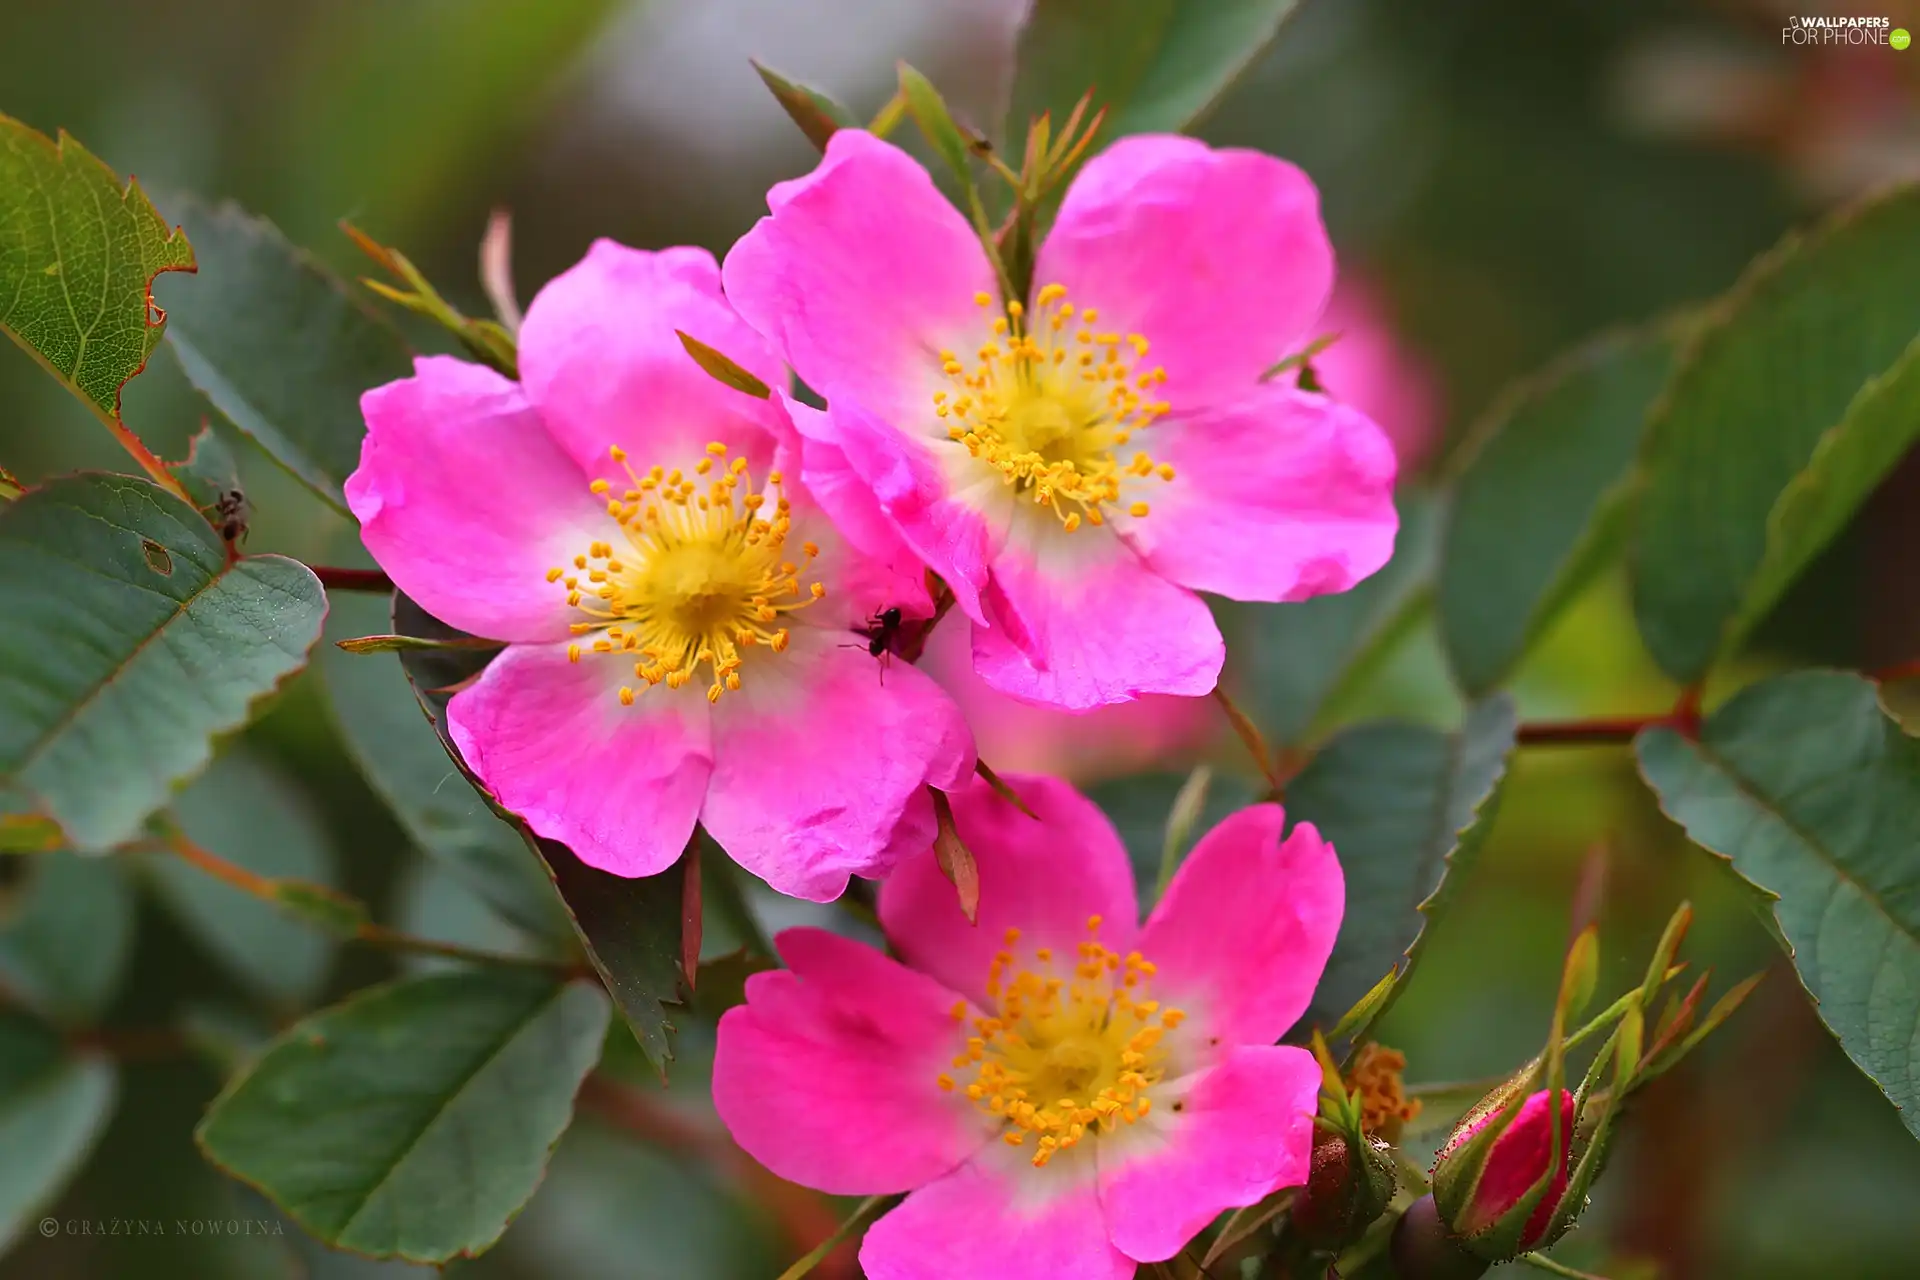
left=933, top=284, right=1173, bottom=533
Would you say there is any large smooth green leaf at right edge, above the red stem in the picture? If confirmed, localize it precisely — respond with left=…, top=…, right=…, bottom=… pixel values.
left=1632, top=186, right=1920, bottom=683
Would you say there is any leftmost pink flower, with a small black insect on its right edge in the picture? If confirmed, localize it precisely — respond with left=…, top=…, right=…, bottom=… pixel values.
left=346, top=240, right=973, bottom=900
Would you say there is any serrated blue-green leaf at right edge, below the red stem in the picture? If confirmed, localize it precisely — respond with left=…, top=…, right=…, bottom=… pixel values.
left=1638, top=672, right=1920, bottom=1136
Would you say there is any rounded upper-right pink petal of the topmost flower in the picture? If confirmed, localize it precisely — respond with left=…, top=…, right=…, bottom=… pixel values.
left=1033, top=134, right=1332, bottom=413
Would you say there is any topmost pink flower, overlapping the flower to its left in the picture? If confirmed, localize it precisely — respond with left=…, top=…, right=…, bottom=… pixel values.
left=724, top=129, right=1396, bottom=710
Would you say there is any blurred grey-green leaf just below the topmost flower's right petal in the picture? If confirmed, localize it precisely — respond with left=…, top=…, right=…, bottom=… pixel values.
left=1223, top=491, right=1440, bottom=747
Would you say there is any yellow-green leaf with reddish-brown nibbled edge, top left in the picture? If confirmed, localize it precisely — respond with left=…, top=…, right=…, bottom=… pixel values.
left=0, top=115, right=194, bottom=422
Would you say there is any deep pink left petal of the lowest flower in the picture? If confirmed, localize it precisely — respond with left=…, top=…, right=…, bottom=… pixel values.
left=712, top=929, right=995, bottom=1196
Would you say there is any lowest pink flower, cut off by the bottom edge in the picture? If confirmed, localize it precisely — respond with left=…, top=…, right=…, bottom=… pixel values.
left=714, top=777, right=1344, bottom=1280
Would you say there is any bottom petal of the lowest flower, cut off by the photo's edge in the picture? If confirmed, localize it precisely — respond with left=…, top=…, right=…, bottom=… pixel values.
left=860, top=1148, right=1133, bottom=1280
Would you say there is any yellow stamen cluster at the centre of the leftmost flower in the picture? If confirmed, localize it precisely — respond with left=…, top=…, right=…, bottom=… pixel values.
left=547, top=443, right=828, bottom=706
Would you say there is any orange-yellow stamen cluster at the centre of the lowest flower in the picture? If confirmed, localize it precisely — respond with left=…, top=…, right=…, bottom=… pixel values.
left=939, top=915, right=1187, bottom=1169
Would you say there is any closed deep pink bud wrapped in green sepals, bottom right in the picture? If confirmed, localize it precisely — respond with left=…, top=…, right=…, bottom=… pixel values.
left=1432, top=1090, right=1574, bottom=1261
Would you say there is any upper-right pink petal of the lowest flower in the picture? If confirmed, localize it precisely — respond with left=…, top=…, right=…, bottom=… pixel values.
left=1139, top=804, right=1346, bottom=1046
